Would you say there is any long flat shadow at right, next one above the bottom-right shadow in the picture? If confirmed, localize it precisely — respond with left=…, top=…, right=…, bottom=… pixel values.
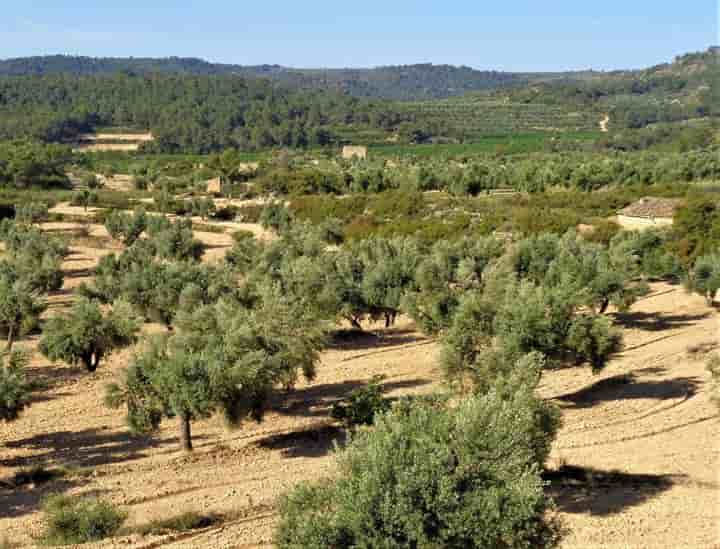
left=556, top=374, right=700, bottom=408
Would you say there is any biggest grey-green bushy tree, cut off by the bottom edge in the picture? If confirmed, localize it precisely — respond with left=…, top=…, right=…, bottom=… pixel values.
left=275, top=372, right=559, bottom=549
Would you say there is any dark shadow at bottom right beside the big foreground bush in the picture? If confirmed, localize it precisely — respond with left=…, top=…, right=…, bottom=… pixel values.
left=543, top=465, right=685, bottom=516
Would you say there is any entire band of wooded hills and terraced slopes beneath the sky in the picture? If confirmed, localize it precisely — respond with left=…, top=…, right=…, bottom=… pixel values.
left=0, top=46, right=720, bottom=153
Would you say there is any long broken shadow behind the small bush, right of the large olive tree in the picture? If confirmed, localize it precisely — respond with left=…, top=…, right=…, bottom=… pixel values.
left=270, top=378, right=431, bottom=417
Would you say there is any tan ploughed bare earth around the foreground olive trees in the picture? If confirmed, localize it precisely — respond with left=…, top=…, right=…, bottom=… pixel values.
left=0, top=225, right=720, bottom=549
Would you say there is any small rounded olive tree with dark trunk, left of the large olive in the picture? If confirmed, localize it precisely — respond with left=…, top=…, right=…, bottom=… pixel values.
left=40, top=297, right=140, bottom=372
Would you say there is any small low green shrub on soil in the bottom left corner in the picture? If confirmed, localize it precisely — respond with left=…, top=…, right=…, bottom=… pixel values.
left=42, top=494, right=127, bottom=545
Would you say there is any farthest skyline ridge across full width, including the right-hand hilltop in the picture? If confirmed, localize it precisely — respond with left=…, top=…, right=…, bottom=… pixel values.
left=0, top=48, right=718, bottom=101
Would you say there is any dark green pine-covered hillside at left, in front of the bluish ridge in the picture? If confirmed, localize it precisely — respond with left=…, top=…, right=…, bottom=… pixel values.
left=0, top=73, right=422, bottom=153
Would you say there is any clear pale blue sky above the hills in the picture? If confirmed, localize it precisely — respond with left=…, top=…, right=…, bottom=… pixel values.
left=0, top=0, right=720, bottom=71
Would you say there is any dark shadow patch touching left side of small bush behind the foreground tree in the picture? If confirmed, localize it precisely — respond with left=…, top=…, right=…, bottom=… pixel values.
left=255, top=424, right=347, bottom=458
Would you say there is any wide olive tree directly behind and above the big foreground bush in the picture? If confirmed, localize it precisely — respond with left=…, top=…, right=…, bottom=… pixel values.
left=441, top=268, right=621, bottom=388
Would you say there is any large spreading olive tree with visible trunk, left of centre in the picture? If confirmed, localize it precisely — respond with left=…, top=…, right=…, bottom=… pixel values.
left=106, top=289, right=322, bottom=451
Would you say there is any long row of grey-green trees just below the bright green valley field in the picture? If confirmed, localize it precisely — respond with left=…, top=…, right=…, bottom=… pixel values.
left=249, top=147, right=720, bottom=196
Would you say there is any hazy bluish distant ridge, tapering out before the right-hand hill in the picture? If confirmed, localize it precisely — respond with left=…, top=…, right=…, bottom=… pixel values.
left=0, top=55, right=538, bottom=100
